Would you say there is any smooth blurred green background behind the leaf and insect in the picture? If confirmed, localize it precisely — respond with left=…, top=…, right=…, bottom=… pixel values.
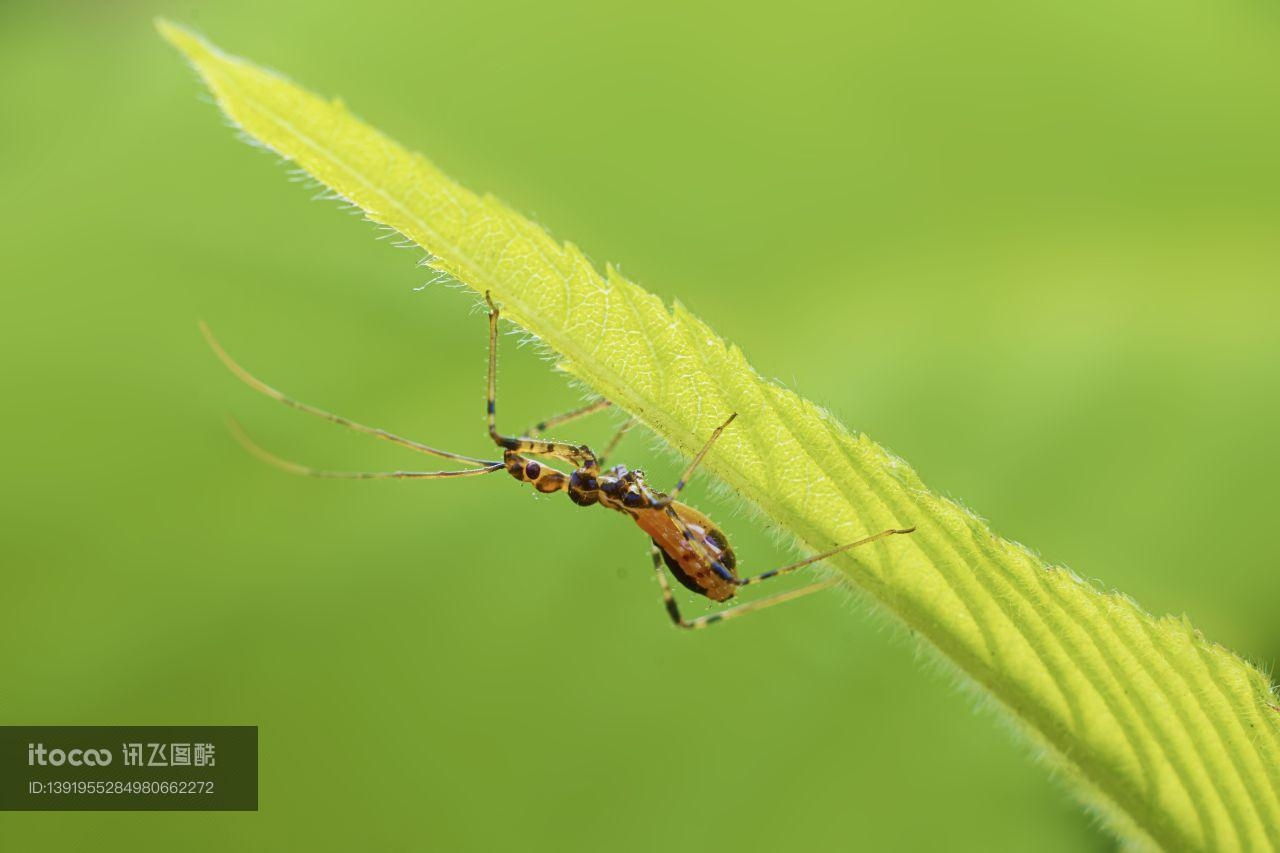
left=0, top=0, right=1280, bottom=850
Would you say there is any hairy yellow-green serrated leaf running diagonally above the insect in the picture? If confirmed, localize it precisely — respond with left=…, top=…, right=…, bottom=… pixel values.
left=160, top=22, right=1280, bottom=850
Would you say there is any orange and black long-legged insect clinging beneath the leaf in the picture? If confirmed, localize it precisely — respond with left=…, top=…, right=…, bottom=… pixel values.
left=201, top=293, right=915, bottom=629
